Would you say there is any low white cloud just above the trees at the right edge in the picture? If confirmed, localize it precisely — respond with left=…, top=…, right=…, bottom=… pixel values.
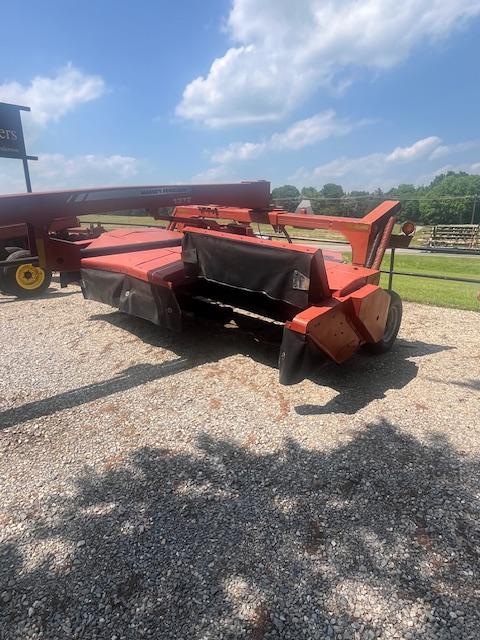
left=290, top=136, right=480, bottom=190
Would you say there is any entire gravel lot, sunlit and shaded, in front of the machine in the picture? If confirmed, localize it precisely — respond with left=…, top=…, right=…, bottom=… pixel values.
left=0, top=285, right=480, bottom=640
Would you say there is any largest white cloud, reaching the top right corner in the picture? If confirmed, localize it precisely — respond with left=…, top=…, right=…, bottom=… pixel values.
left=177, top=0, right=480, bottom=127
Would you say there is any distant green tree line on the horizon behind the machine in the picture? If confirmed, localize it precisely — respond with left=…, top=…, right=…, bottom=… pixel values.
left=272, top=171, right=480, bottom=224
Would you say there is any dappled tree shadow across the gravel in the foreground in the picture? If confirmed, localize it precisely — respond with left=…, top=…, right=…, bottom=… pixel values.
left=0, top=422, right=480, bottom=640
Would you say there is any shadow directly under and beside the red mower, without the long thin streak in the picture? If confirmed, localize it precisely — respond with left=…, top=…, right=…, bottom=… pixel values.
left=91, top=310, right=454, bottom=415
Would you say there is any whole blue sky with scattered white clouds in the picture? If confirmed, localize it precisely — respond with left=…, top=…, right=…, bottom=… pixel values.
left=0, top=0, right=480, bottom=193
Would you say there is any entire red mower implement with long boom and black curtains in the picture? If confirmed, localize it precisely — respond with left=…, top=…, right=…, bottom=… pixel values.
left=0, top=182, right=411, bottom=384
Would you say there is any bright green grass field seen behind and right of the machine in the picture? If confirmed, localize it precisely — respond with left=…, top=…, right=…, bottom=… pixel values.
left=82, top=215, right=480, bottom=311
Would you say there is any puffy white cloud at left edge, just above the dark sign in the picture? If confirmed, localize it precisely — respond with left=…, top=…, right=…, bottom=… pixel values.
left=0, top=64, right=105, bottom=127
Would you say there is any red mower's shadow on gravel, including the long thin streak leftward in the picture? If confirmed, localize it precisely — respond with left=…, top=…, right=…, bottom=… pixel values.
left=0, top=312, right=452, bottom=430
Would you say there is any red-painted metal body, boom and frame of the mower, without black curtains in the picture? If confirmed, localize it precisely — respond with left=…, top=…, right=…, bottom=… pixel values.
left=0, top=182, right=400, bottom=382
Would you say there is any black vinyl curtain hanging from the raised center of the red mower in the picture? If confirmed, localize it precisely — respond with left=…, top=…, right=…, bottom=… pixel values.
left=182, top=231, right=325, bottom=308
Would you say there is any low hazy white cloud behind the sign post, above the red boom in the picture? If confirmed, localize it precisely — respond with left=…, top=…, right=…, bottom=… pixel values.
left=0, top=153, right=140, bottom=193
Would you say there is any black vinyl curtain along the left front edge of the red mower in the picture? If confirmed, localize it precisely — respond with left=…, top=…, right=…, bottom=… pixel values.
left=80, top=269, right=182, bottom=331
